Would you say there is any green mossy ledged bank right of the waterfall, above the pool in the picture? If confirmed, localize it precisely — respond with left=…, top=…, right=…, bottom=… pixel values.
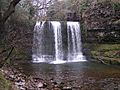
left=83, top=43, right=120, bottom=64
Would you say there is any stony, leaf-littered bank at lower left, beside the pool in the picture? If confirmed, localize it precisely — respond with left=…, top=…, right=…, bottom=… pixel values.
left=0, top=64, right=72, bottom=90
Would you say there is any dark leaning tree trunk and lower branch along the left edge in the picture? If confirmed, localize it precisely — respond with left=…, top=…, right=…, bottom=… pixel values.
left=0, top=0, right=21, bottom=68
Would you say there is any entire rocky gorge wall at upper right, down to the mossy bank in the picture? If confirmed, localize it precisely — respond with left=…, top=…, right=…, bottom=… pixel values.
left=82, top=1, right=120, bottom=42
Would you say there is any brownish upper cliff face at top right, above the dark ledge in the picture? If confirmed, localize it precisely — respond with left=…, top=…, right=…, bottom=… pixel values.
left=82, top=1, right=120, bottom=30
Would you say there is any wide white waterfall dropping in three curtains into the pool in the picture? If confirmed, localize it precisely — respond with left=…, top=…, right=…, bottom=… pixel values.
left=32, top=21, right=86, bottom=64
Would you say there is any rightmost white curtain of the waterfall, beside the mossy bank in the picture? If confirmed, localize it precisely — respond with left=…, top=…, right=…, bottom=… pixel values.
left=67, top=22, right=86, bottom=62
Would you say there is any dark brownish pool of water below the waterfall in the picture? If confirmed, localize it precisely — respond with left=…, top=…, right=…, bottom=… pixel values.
left=15, top=62, right=120, bottom=90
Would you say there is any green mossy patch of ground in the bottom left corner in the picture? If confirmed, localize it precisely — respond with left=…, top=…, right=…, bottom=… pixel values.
left=0, top=72, right=13, bottom=90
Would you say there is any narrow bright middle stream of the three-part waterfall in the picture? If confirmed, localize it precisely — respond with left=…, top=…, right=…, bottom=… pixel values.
left=51, top=21, right=65, bottom=64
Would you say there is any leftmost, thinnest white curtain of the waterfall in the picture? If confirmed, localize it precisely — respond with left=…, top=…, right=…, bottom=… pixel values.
left=32, top=21, right=45, bottom=63
